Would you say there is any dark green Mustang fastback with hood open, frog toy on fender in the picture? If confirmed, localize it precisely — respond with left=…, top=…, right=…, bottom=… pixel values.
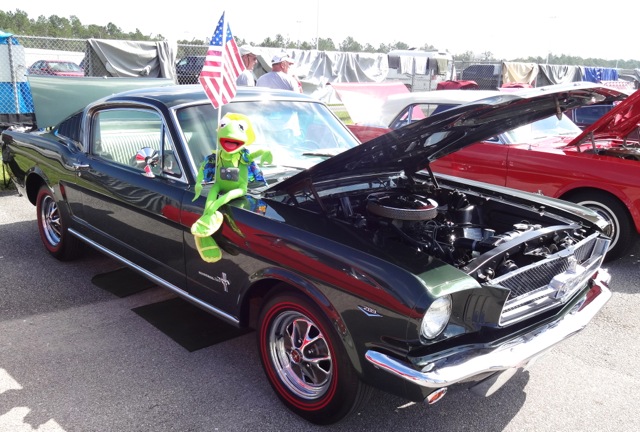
left=2, top=83, right=611, bottom=424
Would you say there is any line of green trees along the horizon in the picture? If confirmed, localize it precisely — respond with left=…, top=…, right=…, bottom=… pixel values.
left=0, top=9, right=640, bottom=69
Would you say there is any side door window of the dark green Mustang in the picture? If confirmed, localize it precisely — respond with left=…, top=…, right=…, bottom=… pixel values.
left=91, top=108, right=182, bottom=177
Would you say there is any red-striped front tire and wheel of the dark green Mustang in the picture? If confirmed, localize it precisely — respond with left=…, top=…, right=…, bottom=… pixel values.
left=258, top=293, right=370, bottom=424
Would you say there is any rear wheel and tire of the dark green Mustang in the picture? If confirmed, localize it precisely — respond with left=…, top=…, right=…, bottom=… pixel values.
left=36, top=185, right=80, bottom=261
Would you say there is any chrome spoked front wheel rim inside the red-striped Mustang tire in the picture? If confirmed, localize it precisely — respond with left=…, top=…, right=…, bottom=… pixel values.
left=267, top=310, right=333, bottom=400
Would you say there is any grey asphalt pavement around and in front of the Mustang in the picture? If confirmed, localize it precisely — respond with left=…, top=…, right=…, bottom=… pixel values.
left=0, top=192, right=640, bottom=432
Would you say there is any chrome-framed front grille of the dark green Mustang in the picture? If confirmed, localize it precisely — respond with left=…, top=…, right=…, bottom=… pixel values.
left=491, top=234, right=609, bottom=326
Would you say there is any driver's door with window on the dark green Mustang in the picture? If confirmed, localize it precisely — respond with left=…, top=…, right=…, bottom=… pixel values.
left=80, top=107, right=188, bottom=286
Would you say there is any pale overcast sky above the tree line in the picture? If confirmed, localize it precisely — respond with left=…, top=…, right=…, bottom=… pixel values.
left=6, top=0, right=640, bottom=60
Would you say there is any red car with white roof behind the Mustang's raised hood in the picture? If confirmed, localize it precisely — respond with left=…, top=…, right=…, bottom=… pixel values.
left=340, top=83, right=640, bottom=259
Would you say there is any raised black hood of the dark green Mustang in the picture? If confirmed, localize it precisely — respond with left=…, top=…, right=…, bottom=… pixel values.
left=269, top=83, right=607, bottom=193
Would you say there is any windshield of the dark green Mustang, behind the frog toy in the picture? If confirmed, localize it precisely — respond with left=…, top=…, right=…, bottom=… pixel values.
left=177, top=100, right=359, bottom=177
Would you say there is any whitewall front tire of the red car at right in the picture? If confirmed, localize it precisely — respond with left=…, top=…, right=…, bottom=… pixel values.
left=567, top=191, right=638, bottom=261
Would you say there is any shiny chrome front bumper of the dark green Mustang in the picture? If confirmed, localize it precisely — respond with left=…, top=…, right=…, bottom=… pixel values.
left=365, top=269, right=611, bottom=389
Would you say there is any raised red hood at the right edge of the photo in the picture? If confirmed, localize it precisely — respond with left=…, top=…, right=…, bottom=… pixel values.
left=570, top=91, right=640, bottom=145
